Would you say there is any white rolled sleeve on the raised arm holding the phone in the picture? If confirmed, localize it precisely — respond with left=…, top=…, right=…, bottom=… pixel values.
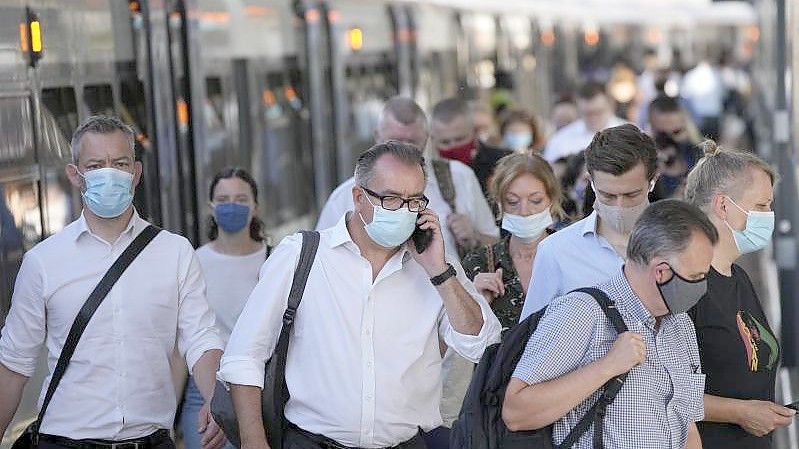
left=438, top=260, right=502, bottom=363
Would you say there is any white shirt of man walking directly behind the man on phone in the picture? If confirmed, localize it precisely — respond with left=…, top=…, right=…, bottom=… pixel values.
left=316, top=161, right=499, bottom=256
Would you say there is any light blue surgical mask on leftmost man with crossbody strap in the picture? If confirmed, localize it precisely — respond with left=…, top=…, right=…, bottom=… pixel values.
left=75, top=167, right=133, bottom=218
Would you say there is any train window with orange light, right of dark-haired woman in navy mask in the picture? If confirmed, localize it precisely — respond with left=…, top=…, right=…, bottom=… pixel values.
left=260, top=72, right=313, bottom=228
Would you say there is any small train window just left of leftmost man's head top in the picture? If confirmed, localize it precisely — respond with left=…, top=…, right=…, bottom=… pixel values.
left=41, top=87, right=78, bottom=161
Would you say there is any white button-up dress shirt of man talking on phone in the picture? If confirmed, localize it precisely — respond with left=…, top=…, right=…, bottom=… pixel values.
left=218, top=217, right=501, bottom=448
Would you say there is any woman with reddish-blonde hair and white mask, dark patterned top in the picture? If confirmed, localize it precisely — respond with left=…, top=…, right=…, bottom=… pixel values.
left=463, top=154, right=563, bottom=330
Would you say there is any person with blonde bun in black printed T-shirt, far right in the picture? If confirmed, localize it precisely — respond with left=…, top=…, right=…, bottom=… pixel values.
left=685, top=142, right=794, bottom=449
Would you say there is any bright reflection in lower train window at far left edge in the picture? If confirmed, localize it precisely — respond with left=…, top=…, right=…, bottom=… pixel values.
left=0, top=179, right=42, bottom=327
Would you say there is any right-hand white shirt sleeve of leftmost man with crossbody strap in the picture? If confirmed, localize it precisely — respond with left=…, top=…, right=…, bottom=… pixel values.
left=178, top=241, right=224, bottom=373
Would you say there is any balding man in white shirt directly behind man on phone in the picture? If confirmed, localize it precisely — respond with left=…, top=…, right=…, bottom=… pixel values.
left=316, top=97, right=499, bottom=255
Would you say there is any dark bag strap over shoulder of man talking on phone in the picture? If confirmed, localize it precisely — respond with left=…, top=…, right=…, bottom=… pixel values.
left=269, top=231, right=319, bottom=447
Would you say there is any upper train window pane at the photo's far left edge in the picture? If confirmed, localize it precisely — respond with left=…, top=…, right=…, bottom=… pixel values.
left=0, top=96, right=36, bottom=168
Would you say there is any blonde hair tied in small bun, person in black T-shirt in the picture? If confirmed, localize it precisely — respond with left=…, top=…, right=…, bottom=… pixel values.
left=685, top=140, right=779, bottom=210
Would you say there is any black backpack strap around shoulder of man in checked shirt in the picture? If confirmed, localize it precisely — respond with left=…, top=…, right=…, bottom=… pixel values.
left=558, top=287, right=627, bottom=449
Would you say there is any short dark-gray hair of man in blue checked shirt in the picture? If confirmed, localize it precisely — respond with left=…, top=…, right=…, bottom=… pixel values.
left=627, top=199, right=719, bottom=265
